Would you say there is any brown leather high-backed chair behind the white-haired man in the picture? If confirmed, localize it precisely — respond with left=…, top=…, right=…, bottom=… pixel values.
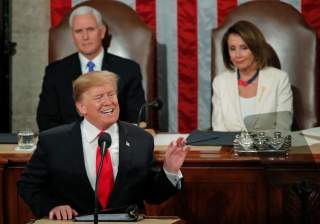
left=49, top=0, right=157, bottom=127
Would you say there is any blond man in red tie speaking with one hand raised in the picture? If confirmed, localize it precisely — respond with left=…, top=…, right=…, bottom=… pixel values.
left=17, top=71, right=189, bottom=219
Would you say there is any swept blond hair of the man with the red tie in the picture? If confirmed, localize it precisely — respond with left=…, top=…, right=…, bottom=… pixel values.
left=73, top=71, right=119, bottom=102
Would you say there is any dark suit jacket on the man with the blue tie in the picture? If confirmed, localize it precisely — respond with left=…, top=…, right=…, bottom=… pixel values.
left=37, top=51, right=145, bottom=131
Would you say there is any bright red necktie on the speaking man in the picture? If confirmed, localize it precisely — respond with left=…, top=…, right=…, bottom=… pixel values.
left=96, top=140, right=114, bottom=209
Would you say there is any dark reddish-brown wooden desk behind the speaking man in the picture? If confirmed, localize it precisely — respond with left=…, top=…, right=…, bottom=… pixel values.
left=0, top=146, right=320, bottom=224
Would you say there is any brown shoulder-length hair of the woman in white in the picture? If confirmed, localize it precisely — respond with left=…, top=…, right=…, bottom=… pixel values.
left=221, top=20, right=268, bottom=70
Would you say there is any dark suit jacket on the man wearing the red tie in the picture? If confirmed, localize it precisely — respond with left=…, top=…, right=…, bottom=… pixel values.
left=17, top=122, right=176, bottom=217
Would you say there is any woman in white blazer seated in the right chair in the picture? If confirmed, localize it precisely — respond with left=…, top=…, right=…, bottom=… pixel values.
left=212, top=21, right=292, bottom=131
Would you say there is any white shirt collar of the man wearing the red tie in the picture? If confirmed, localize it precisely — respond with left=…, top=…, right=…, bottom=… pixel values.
left=81, top=119, right=118, bottom=143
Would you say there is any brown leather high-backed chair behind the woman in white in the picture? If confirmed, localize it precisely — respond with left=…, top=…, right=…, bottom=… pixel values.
left=211, top=1, right=320, bottom=130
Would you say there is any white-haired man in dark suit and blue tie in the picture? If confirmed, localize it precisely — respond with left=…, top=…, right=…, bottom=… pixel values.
left=37, top=6, right=145, bottom=131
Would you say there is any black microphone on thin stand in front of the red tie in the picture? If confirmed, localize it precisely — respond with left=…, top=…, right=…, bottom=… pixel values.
left=93, top=132, right=112, bottom=224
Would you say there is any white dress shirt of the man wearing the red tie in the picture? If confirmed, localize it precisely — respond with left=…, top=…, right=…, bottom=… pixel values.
left=80, top=119, right=182, bottom=190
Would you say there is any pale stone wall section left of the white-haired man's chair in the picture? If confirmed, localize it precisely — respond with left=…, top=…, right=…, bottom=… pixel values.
left=12, top=0, right=50, bottom=132
